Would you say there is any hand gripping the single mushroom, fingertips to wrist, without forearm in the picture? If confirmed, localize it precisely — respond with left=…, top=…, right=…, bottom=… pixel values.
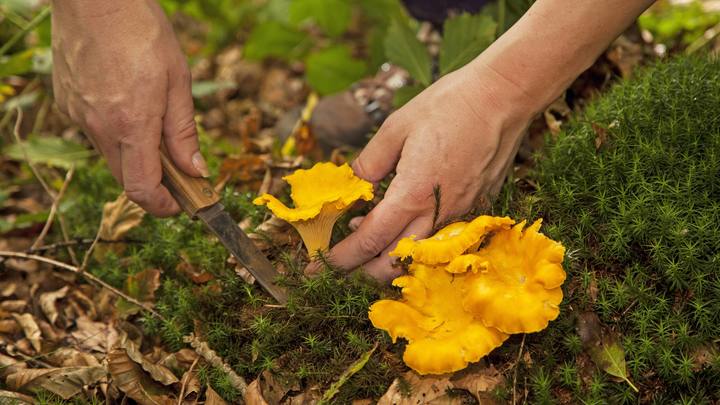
left=306, top=61, right=535, bottom=281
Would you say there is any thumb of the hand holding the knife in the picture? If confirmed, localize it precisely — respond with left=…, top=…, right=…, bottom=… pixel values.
left=163, top=66, right=210, bottom=177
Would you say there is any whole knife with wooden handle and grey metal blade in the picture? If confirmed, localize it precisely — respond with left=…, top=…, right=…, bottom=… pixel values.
left=160, top=148, right=287, bottom=304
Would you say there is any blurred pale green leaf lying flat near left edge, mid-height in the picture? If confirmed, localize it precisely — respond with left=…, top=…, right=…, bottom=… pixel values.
left=5, top=136, right=93, bottom=169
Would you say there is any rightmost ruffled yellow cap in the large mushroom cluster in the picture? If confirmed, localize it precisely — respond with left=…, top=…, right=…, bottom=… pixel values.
left=462, top=220, right=565, bottom=333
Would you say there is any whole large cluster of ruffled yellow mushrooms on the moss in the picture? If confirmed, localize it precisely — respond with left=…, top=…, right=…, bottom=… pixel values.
left=369, top=216, right=565, bottom=374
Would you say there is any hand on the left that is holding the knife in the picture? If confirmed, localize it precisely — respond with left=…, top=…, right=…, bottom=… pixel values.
left=52, top=0, right=208, bottom=216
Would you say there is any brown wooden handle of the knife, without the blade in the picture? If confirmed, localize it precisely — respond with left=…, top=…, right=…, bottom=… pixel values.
left=160, top=147, right=220, bottom=218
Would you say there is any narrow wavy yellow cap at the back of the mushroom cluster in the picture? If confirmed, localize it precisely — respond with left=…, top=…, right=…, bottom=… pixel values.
left=390, top=215, right=515, bottom=265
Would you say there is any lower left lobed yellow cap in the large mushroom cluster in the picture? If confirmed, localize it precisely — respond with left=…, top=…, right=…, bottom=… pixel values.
left=368, top=263, right=508, bottom=374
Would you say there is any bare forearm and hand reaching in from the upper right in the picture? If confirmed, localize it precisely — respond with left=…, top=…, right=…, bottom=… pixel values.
left=316, top=0, right=653, bottom=281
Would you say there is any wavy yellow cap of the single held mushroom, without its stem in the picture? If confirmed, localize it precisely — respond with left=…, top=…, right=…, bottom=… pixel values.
left=253, top=162, right=373, bottom=222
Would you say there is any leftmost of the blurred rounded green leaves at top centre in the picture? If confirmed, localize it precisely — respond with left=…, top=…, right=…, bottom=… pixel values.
left=245, top=21, right=307, bottom=60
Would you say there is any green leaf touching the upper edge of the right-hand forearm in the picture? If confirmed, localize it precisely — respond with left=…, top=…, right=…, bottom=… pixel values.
left=440, top=13, right=497, bottom=75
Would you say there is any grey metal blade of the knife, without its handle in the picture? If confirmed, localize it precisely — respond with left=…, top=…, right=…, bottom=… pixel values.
left=195, top=203, right=287, bottom=304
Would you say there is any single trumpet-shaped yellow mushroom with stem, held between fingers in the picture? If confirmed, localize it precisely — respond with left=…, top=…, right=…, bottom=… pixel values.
left=253, top=163, right=373, bottom=256
